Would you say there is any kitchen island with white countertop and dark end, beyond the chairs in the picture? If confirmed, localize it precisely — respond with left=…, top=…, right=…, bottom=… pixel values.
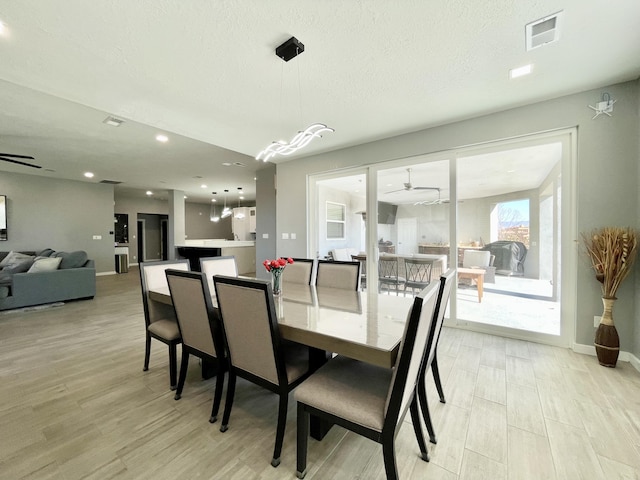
left=176, top=239, right=256, bottom=275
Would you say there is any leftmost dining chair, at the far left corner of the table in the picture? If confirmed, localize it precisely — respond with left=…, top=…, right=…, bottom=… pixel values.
left=140, top=259, right=189, bottom=390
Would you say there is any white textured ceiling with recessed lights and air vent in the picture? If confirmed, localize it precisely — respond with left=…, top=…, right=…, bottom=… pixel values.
left=0, top=0, right=640, bottom=200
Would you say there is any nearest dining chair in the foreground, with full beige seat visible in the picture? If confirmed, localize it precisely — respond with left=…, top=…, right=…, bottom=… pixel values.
left=295, top=284, right=437, bottom=480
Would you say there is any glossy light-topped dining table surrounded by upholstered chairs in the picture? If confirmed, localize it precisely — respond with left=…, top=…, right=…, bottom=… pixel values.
left=148, top=282, right=413, bottom=440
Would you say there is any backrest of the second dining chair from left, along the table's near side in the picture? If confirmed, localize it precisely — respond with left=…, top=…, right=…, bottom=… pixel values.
left=166, top=270, right=218, bottom=357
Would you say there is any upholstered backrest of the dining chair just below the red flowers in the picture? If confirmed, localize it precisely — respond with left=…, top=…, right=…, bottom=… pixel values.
left=213, top=276, right=278, bottom=384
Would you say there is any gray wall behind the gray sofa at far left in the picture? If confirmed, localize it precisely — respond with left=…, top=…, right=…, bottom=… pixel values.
left=0, top=172, right=115, bottom=272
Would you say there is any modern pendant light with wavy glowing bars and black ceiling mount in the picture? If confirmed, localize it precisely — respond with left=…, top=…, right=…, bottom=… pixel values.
left=256, top=37, right=335, bottom=162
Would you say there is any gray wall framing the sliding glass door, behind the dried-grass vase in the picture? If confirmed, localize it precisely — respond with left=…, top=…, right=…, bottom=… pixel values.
left=277, top=81, right=640, bottom=357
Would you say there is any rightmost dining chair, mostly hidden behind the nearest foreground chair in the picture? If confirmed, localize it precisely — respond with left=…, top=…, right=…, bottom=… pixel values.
left=417, top=269, right=456, bottom=444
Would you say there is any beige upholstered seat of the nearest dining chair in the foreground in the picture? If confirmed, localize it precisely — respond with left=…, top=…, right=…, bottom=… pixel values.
left=295, top=356, right=393, bottom=431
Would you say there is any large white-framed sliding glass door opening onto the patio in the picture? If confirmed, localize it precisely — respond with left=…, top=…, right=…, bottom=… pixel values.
left=309, top=130, right=576, bottom=345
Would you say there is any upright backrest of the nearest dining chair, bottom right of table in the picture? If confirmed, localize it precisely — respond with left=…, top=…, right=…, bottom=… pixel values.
left=385, top=282, right=440, bottom=421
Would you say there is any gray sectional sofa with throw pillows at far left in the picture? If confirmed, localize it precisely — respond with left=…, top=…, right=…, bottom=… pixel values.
left=0, top=249, right=96, bottom=310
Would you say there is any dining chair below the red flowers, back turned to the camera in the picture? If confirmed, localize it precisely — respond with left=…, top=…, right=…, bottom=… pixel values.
left=213, top=275, right=310, bottom=467
